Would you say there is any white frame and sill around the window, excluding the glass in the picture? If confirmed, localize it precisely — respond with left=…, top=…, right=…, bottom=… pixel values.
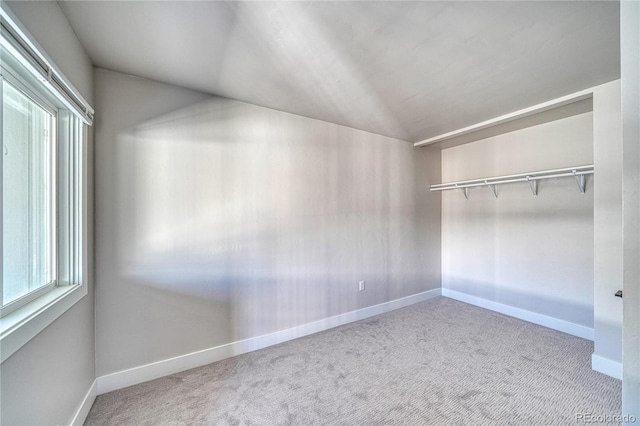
left=0, top=3, right=93, bottom=362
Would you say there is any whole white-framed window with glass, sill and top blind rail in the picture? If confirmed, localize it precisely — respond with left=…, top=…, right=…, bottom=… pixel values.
left=0, top=4, right=93, bottom=361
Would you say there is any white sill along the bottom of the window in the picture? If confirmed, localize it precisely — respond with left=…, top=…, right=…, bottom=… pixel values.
left=0, top=285, right=87, bottom=363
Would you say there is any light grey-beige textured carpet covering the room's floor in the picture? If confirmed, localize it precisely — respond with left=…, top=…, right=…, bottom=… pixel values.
left=86, top=297, right=621, bottom=425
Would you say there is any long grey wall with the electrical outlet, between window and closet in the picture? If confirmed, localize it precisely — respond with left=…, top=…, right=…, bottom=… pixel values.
left=95, top=70, right=440, bottom=376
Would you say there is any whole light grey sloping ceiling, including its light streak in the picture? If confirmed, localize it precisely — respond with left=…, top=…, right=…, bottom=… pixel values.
left=59, top=1, right=620, bottom=142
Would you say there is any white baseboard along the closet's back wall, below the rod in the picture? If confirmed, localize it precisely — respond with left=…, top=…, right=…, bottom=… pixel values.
left=442, top=288, right=593, bottom=341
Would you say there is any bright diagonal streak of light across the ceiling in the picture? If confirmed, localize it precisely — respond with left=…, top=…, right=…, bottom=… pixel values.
left=221, top=2, right=408, bottom=138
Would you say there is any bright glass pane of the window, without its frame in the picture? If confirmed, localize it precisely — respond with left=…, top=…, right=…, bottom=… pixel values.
left=2, top=81, right=55, bottom=305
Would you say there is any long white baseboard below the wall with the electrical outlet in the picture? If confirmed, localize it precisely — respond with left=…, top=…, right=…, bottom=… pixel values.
left=96, top=288, right=442, bottom=395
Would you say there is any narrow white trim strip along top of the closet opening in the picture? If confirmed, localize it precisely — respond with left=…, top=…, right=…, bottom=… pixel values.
left=413, top=88, right=594, bottom=146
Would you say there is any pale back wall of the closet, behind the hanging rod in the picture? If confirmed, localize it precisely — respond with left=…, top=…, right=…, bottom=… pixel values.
left=442, top=112, right=598, bottom=327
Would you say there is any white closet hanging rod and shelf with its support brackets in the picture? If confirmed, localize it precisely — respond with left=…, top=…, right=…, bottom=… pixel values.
left=431, top=164, right=594, bottom=200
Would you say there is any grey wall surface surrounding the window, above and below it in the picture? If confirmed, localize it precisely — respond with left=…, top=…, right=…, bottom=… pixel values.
left=0, top=2, right=95, bottom=425
